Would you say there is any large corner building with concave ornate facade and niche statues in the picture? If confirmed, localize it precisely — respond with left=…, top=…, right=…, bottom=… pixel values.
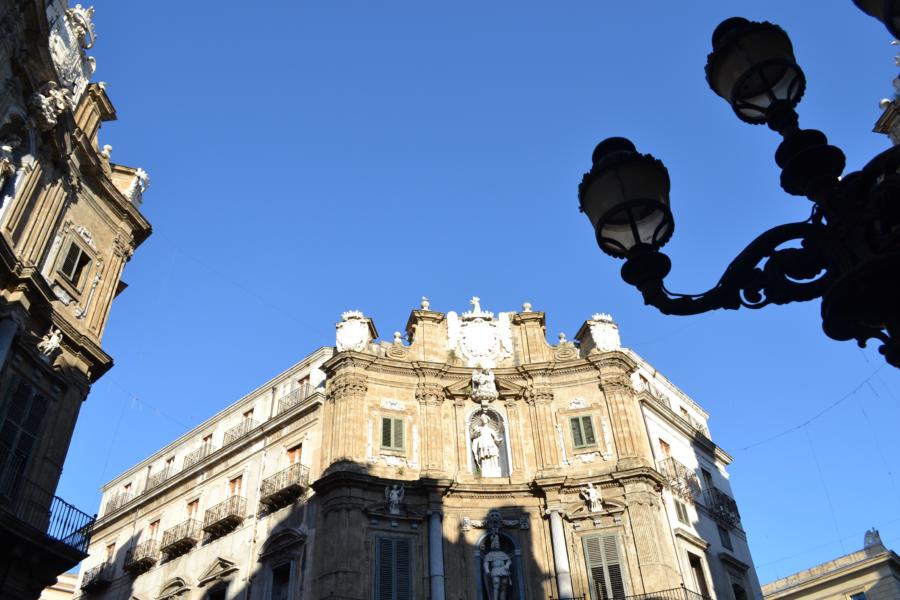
left=79, top=298, right=761, bottom=600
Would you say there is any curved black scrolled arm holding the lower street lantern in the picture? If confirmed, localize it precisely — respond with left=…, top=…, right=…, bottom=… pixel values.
left=623, top=221, right=833, bottom=315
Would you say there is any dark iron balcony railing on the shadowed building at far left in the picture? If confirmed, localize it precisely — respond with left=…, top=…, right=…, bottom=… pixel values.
left=0, top=448, right=95, bottom=554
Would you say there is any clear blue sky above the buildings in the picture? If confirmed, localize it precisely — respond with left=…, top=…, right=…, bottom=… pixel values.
left=59, top=0, right=900, bottom=581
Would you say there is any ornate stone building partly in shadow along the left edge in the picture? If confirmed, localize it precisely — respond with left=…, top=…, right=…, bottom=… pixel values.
left=0, top=0, right=150, bottom=600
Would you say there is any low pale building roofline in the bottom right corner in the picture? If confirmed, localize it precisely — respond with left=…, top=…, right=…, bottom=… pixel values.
left=762, top=529, right=900, bottom=600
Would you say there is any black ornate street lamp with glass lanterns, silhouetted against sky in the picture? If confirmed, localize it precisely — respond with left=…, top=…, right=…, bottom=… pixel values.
left=578, top=15, right=900, bottom=368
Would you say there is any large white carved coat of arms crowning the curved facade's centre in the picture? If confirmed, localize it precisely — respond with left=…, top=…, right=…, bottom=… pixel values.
left=447, top=296, right=512, bottom=369
